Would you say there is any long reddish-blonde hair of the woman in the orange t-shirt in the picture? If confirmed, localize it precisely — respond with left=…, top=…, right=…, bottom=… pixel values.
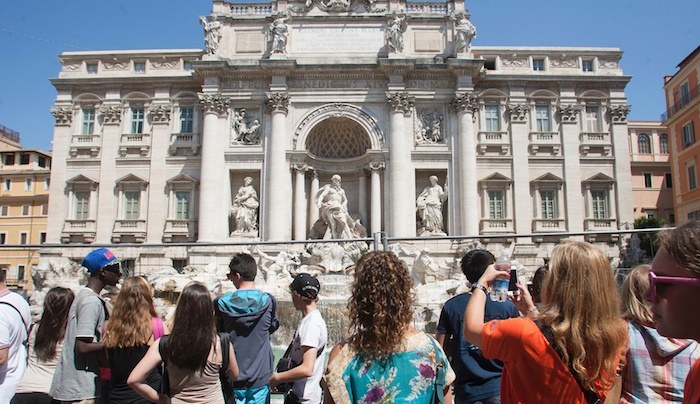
left=540, top=241, right=627, bottom=390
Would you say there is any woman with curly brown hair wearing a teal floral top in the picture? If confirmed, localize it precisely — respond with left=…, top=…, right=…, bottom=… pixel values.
left=325, top=252, right=455, bottom=403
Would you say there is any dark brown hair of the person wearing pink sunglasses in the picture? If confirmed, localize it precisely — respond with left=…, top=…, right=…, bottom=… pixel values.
left=659, top=220, right=700, bottom=277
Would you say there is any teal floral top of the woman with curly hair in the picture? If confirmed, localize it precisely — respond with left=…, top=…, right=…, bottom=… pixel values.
left=325, top=332, right=455, bottom=404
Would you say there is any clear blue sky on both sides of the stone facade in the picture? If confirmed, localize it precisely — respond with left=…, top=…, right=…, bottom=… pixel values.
left=0, top=0, right=700, bottom=150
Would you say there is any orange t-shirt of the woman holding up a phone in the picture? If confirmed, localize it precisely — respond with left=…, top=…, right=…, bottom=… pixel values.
left=481, top=318, right=607, bottom=404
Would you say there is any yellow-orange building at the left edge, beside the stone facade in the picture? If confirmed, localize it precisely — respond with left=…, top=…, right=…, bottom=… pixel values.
left=0, top=126, right=51, bottom=288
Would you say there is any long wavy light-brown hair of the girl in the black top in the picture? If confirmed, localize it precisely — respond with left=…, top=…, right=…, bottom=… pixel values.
left=104, top=276, right=157, bottom=348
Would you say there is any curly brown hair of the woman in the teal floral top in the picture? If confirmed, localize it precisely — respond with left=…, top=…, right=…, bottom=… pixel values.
left=348, top=251, right=413, bottom=360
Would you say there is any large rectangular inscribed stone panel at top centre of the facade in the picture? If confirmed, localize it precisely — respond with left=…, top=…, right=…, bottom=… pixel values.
left=291, top=27, right=384, bottom=53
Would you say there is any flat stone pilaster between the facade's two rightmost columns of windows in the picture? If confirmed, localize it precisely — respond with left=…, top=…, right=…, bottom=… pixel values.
left=558, top=105, right=584, bottom=234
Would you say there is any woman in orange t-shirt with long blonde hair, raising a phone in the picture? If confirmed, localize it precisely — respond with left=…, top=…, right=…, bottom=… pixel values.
left=464, top=241, right=627, bottom=404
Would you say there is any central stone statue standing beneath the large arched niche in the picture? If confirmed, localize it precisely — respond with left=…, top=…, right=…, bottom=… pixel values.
left=309, top=174, right=366, bottom=239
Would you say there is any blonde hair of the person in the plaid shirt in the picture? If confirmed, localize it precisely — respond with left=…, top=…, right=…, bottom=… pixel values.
left=620, top=264, right=654, bottom=327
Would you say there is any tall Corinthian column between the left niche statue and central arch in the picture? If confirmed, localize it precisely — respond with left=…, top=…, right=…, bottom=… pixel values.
left=262, top=91, right=292, bottom=241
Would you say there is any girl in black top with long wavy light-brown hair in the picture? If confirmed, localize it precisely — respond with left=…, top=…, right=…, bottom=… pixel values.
left=104, top=276, right=167, bottom=403
